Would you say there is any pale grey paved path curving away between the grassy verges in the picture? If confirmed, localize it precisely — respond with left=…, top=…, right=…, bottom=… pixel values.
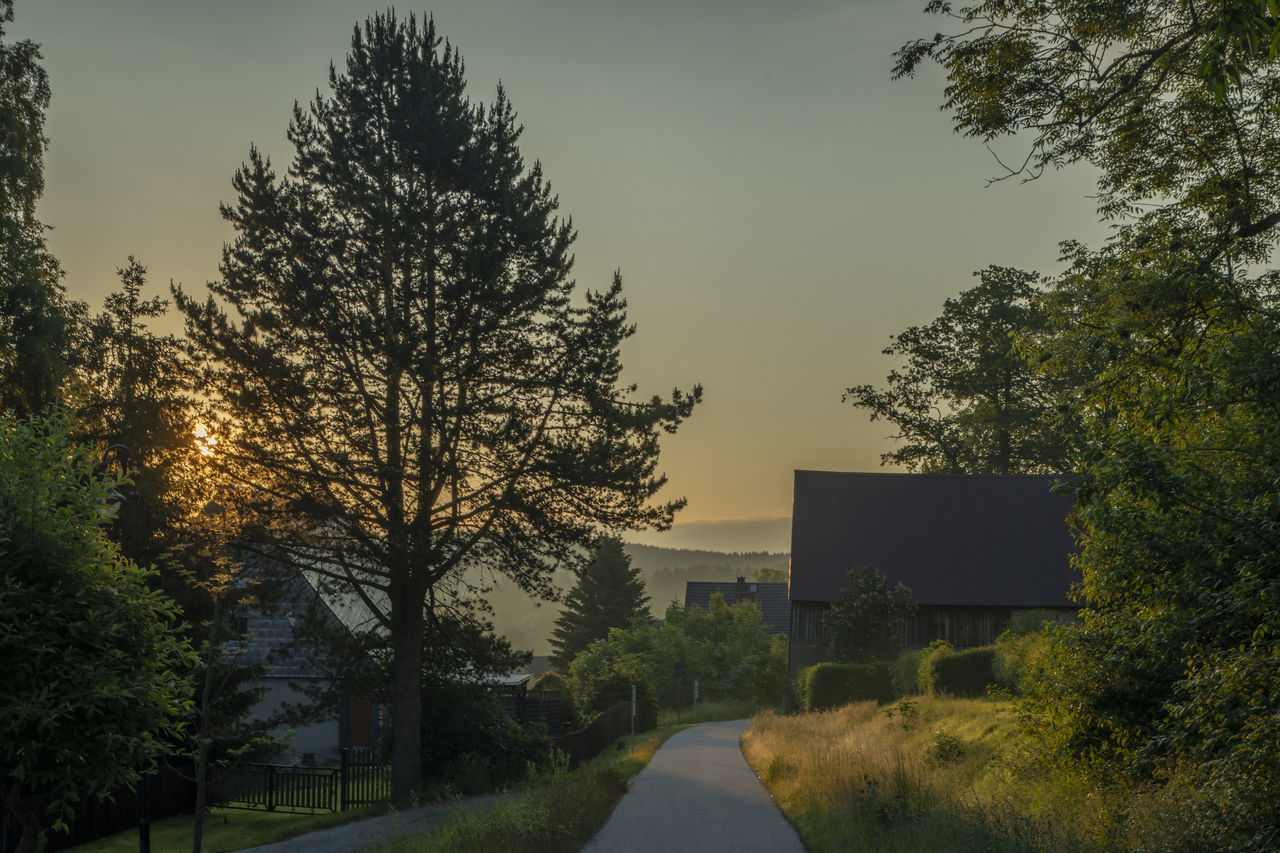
left=582, top=720, right=804, bottom=853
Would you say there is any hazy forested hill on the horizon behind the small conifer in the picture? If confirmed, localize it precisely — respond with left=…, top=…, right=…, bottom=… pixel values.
left=489, top=543, right=790, bottom=654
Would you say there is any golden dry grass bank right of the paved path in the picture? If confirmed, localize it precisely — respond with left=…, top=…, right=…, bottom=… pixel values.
left=744, top=698, right=1178, bottom=853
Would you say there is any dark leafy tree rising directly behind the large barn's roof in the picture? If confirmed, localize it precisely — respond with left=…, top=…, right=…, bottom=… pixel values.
left=845, top=266, right=1074, bottom=474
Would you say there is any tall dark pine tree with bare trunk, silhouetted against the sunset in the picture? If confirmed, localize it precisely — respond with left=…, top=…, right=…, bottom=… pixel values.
left=177, top=13, right=699, bottom=795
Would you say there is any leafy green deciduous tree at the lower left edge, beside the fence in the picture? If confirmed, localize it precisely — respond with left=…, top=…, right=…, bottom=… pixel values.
left=0, top=415, right=191, bottom=853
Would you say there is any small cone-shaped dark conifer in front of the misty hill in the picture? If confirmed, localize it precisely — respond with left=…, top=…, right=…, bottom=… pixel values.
left=550, top=538, right=649, bottom=672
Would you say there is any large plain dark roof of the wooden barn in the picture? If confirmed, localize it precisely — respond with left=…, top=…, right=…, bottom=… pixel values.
left=790, top=471, right=1079, bottom=607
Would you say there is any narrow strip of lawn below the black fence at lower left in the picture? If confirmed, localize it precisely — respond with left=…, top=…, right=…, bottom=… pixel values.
left=69, top=806, right=381, bottom=853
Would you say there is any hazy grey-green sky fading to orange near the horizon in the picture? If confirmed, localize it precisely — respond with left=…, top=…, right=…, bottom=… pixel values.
left=9, top=0, right=1105, bottom=551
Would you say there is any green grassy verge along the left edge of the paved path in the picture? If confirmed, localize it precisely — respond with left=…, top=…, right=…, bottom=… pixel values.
left=366, top=724, right=690, bottom=853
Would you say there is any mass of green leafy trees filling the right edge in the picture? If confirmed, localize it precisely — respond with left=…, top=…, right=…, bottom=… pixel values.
left=897, top=0, right=1280, bottom=849
